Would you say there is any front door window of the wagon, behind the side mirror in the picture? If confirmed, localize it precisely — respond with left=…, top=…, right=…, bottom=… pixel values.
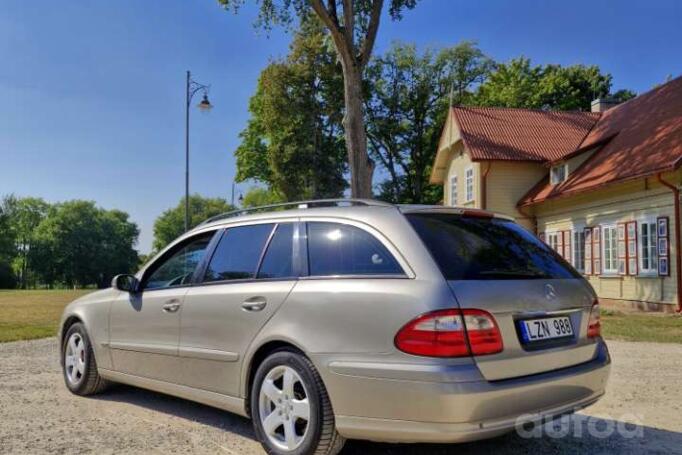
left=143, top=232, right=215, bottom=289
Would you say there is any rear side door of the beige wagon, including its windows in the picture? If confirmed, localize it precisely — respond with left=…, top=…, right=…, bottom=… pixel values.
left=179, top=220, right=297, bottom=396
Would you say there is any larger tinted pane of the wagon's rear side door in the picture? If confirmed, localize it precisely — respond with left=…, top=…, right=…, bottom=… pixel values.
left=204, top=224, right=273, bottom=281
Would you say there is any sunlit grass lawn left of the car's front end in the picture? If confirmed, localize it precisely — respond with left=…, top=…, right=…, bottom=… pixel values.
left=0, top=290, right=92, bottom=342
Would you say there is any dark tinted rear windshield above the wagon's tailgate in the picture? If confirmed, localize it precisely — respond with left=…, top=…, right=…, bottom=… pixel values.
left=406, top=213, right=580, bottom=280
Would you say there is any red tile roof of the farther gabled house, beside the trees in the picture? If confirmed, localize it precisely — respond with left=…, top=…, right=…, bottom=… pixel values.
left=452, top=106, right=600, bottom=162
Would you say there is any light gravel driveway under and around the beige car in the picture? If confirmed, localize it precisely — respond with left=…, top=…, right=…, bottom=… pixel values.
left=0, top=339, right=682, bottom=455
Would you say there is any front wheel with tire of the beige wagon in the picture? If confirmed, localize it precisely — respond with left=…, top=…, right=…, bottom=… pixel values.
left=62, top=322, right=109, bottom=396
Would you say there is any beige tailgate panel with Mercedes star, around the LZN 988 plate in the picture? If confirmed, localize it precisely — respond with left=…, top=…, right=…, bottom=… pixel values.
left=448, top=279, right=597, bottom=381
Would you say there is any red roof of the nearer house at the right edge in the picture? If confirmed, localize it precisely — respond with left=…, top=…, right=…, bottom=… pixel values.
left=519, top=77, right=682, bottom=205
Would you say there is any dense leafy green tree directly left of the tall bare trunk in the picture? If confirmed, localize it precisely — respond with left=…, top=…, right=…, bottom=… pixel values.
left=235, top=16, right=346, bottom=200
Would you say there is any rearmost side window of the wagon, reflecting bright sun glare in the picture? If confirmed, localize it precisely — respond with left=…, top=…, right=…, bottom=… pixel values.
left=308, top=223, right=404, bottom=276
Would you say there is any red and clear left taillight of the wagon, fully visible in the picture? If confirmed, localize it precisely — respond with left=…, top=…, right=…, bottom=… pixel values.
left=395, top=309, right=503, bottom=357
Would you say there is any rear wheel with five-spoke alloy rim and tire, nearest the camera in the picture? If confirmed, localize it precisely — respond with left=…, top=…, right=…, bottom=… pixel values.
left=250, top=349, right=345, bottom=455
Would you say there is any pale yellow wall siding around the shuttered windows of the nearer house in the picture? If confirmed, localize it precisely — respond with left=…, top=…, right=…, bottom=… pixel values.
left=535, top=175, right=679, bottom=304
